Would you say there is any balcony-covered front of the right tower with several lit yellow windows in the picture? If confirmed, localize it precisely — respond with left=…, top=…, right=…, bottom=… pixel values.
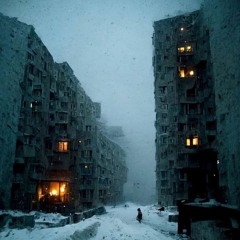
left=153, top=11, right=218, bottom=205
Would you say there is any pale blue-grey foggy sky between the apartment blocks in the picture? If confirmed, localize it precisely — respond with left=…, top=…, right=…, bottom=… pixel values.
left=0, top=0, right=201, bottom=203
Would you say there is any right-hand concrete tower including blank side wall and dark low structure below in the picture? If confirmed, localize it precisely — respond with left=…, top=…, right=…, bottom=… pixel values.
left=153, top=0, right=240, bottom=239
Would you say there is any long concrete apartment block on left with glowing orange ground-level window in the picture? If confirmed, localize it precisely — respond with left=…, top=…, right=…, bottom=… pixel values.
left=0, top=15, right=127, bottom=212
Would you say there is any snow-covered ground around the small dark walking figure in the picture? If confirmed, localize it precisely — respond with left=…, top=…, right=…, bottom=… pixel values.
left=0, top=203, right=185, bottom=240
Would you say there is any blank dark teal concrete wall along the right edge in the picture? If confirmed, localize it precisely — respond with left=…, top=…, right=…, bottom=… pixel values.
left=203, top=0, right=240, bottom=206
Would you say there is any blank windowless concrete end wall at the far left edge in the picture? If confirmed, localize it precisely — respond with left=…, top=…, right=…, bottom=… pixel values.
left=0, top=15, right=30, bottom=208
